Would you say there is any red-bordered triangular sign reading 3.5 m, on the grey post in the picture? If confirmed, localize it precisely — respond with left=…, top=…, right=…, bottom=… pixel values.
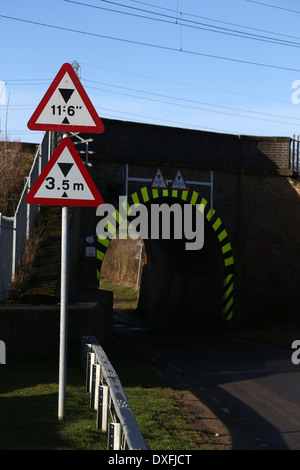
left=26, top=137, right=103, bottom=207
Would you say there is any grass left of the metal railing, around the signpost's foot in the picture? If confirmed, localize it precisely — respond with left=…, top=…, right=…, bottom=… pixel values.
left=0, top=360, right=107, bottom=450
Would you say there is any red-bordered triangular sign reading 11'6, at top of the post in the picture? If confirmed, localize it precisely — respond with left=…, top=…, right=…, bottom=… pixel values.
left=27, top=63, right=104, bottom=134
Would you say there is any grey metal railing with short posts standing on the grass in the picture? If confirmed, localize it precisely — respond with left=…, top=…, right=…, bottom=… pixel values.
left=82, top=336, right=147, bottom=450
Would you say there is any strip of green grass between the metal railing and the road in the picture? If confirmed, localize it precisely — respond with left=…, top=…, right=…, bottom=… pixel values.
left=119, top=366, right=209, bottom=450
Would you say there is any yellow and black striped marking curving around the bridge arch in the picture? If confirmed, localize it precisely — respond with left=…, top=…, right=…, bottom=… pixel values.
left=97, top=186, right=234, bottom=320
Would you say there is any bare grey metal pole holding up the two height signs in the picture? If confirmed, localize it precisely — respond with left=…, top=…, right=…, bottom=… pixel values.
left=58, top=134, right=69, bottom=421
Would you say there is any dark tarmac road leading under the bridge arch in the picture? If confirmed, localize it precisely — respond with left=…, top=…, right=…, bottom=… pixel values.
left=114, top=314, right=300, bottom=450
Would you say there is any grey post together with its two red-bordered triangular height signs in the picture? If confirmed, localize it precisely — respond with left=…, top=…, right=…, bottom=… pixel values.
left=26, top=63, right=104, bottom=420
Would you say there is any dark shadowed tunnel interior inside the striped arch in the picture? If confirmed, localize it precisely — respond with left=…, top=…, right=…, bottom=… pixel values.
left=131, top=198, right=224, bottom=330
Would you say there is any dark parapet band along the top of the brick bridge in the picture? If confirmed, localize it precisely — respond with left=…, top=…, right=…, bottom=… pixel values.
left=76, top=119, right=292, bottom=173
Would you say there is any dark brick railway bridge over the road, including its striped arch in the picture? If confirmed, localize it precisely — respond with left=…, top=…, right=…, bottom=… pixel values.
left=72, top=119, right=300, bottom=327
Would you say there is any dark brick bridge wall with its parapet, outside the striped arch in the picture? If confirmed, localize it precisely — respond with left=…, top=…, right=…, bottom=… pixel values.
left=82, top=120, right=300, bottom=322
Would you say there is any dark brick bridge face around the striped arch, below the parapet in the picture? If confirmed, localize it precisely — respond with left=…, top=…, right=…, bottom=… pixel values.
left=93, top=156, right=300, bottom=322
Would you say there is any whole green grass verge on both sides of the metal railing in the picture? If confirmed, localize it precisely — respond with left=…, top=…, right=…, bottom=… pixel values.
left=0, top=350, right=213, bottom=450
